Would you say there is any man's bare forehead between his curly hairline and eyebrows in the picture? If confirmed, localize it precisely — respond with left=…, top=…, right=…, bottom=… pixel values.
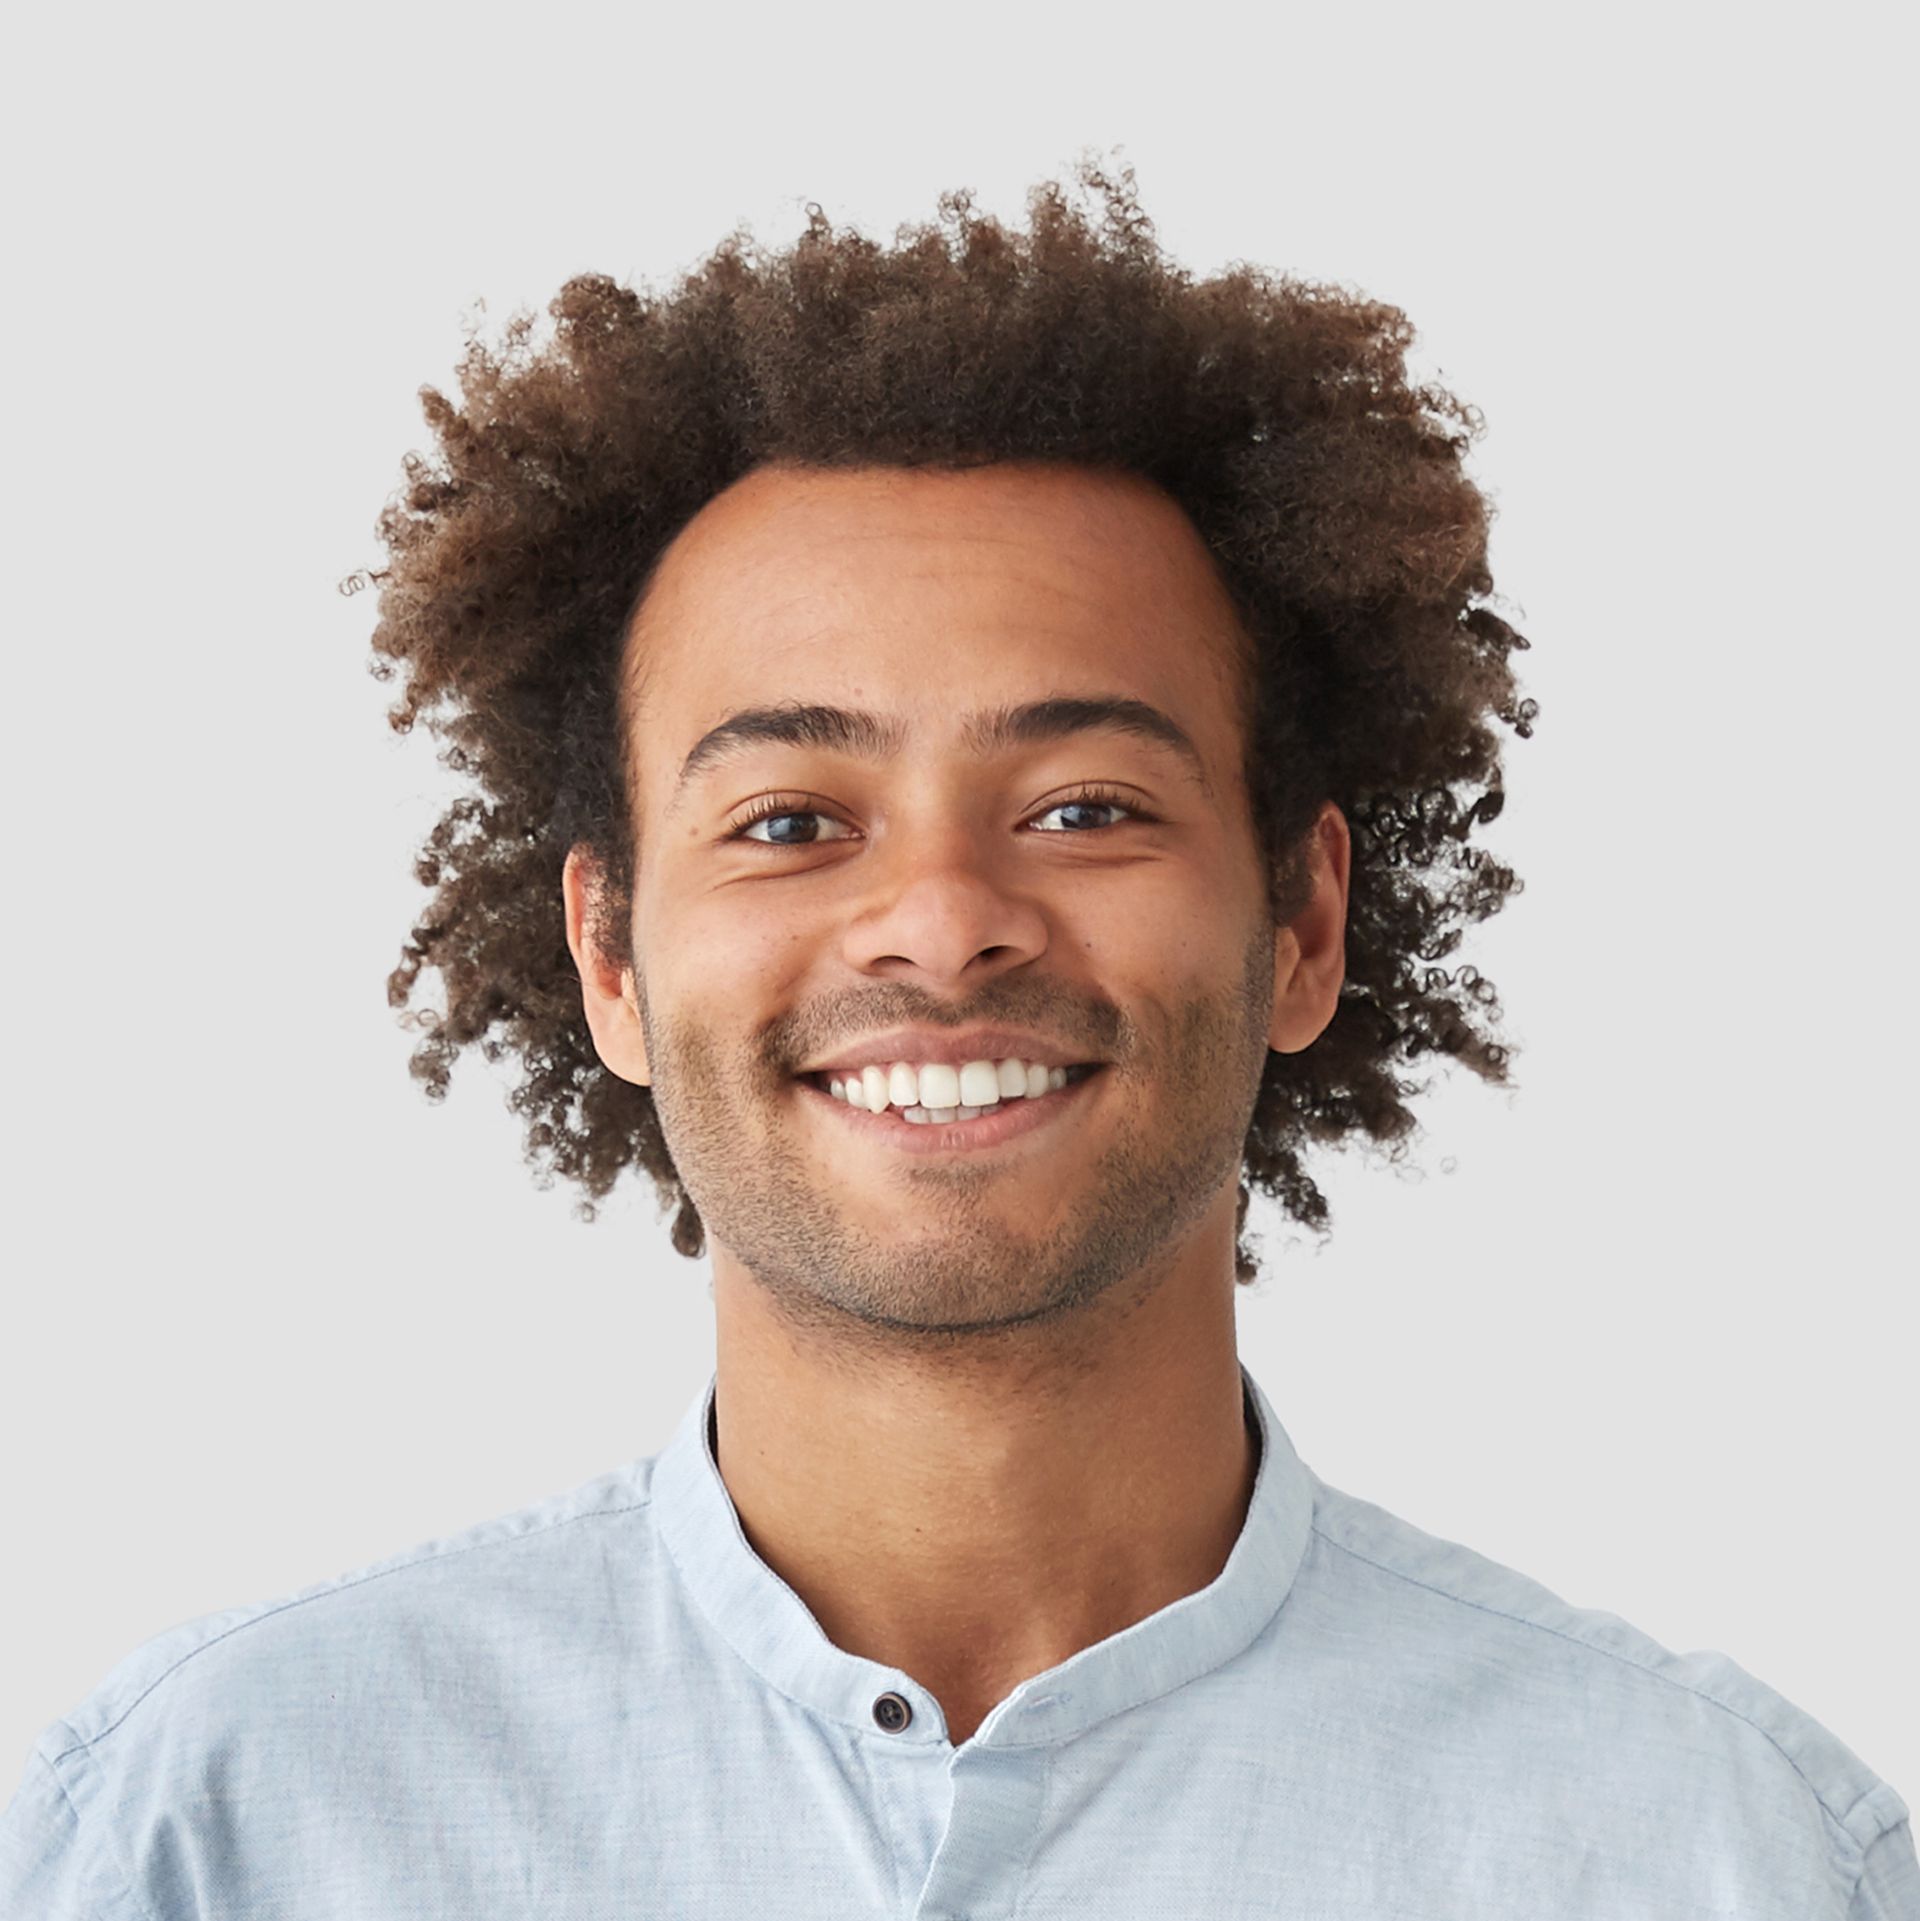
left=628, top=463, right=1243, bottom=799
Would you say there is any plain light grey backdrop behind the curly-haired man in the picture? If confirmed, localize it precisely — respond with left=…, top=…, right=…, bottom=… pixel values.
left=0, top=0, right=1920, bottom=1798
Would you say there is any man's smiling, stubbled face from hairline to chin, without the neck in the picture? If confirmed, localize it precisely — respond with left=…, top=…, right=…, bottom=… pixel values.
left=576, top=465, right=1345, bottom=1339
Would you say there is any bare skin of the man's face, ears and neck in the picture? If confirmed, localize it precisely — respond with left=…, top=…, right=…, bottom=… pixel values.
left=563, top=463, right=1349, bottom=1744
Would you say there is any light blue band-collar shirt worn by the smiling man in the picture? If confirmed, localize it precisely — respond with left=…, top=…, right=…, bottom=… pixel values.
left=0, top=1366, right=1920, bottom=1921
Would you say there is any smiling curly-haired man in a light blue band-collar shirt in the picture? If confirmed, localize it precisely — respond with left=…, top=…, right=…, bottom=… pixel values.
left=0, top=165, right=1920, bottom=1921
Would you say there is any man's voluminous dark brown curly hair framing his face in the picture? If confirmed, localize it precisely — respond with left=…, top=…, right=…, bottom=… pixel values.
left=353, top=158, right=1538, bottom=1285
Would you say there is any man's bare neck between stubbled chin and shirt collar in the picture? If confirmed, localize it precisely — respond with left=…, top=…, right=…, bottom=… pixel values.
left=715, top=1214, right=1259, bottom=1742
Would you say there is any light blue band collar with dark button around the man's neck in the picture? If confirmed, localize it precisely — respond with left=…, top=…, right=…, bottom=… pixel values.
left=652, top=1362, right=1313, bottom=1748
